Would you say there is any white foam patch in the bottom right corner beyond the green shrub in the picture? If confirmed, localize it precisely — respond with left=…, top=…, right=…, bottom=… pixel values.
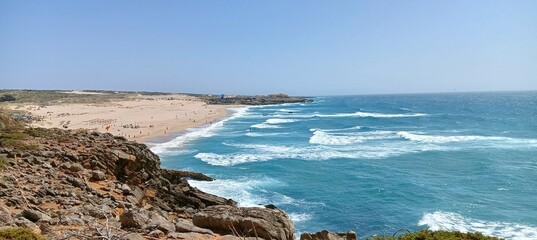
left=418, top=211, right=537, bottom=240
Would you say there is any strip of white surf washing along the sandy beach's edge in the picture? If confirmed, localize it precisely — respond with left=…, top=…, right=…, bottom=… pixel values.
left=151, top=107, right=248, bottom=155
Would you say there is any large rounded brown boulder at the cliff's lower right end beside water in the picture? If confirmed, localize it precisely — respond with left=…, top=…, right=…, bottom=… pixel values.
left=192, top=205, right=295, bottom=240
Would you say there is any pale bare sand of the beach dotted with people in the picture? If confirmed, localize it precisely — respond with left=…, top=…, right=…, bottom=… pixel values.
left=9, top=92, right=231, bottom=142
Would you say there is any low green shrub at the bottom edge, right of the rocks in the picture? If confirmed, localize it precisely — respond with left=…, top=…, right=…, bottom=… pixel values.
left=366, top=230, right=501, bottom=240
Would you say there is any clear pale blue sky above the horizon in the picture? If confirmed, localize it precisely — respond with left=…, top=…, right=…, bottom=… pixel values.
left=0, top=0, right=537, bottom=95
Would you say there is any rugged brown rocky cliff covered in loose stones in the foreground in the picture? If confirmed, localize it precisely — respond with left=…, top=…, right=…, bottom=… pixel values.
left=0, top=118, right=294, bottom=239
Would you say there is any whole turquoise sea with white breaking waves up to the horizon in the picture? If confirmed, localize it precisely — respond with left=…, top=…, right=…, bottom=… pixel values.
left=152, top=92, right=537, bottom=239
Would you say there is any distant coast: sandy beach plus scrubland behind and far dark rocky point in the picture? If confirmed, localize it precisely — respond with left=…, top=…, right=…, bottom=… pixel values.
left=0, top=90, right=311, bottom=143
